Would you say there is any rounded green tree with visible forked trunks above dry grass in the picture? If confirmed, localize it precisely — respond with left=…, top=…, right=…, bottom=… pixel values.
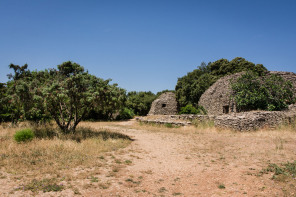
left=42, top=61, right=109, bottom=133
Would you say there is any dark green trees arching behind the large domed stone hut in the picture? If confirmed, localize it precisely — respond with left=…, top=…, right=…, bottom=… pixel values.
left=176, top=57, right=266, bottom=108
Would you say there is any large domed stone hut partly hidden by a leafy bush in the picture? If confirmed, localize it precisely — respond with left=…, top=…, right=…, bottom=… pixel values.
left=198, top=71, right=296, bottom=115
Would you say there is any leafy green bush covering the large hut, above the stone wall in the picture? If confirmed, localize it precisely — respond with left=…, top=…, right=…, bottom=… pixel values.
left=232, top=72, right=295, bottom=111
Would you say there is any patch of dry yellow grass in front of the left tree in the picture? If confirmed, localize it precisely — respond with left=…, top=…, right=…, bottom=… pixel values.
left=0, top=124, right=130, bottom=176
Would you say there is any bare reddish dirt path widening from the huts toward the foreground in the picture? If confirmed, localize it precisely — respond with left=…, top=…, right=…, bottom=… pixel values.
left=84, top=123, right=296, bottom=196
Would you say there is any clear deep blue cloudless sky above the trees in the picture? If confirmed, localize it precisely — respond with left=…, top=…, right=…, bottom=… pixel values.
left=0, top=0, right=296, bottom=92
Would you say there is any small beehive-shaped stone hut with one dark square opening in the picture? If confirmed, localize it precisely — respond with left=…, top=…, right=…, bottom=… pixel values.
left=148, top=92, right=177, bottom=115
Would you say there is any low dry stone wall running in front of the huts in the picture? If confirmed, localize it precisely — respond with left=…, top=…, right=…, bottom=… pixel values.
left=137, top=105, right=296, bottom=131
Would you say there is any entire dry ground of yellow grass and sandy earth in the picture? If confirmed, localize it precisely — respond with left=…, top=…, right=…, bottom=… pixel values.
left=0, top=121, right=296, bottom=196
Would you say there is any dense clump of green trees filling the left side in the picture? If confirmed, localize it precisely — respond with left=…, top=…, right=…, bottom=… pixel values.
left=0, top=61, right=126, bottom=133
